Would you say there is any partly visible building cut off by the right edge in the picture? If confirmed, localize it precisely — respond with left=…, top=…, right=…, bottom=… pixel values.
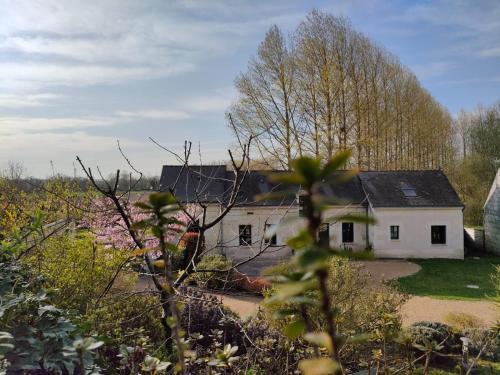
left=484, top=169, right=500, bottom=254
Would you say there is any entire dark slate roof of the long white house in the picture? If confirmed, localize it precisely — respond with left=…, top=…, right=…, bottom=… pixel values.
left=160, top=165, right=463, bottom=207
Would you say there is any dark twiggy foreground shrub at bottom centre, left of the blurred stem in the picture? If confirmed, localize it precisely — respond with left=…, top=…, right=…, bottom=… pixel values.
left=181, top=288, right=313, bottom=374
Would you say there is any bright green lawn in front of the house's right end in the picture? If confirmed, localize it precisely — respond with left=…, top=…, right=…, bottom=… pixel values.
left=397, top=255, right=500, bottom=300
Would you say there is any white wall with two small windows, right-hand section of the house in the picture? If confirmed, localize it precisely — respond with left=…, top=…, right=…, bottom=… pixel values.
left=371, top=207, right=464, bottom=259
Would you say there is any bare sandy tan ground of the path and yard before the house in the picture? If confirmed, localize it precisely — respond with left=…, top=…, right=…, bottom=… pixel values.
left=212, top=260, right=499, bottom=326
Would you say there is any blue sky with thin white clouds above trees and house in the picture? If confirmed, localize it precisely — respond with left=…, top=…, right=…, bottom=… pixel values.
left=0, top=0, right=500, bottom=177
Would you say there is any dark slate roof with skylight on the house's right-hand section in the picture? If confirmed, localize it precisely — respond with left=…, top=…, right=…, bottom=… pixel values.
left=359, top=171, right=463, bottom=207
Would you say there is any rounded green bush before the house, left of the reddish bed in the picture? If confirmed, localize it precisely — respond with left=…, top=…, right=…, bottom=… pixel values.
left=189, top=254, right=233, bottom=290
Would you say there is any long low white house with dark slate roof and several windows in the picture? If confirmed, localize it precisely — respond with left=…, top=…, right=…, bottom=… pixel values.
left=160, top=165, right=464, bottom=272
